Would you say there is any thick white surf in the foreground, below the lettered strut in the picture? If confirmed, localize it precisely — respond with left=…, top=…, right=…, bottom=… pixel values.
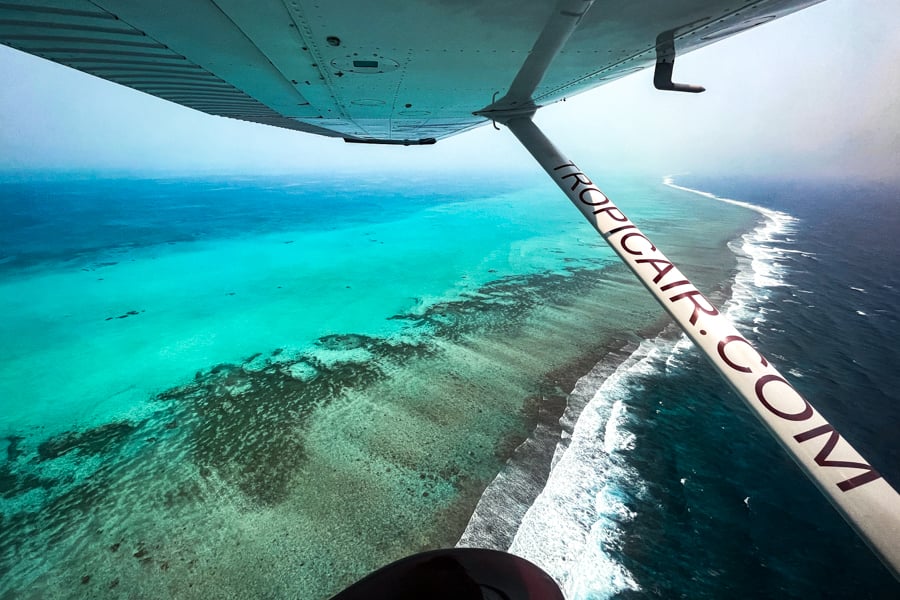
left=509, top=342, right=662, bottom=599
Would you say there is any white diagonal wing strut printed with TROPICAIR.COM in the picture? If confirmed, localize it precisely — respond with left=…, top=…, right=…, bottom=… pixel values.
left=500, top=113, right=900, bottom=580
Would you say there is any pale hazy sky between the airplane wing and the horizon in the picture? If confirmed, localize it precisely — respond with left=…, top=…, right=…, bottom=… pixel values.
left=0, top=0, right=900, bottom=179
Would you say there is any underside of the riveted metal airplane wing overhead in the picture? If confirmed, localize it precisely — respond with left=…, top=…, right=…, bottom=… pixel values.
left=0, top=0, right=820, bottom=144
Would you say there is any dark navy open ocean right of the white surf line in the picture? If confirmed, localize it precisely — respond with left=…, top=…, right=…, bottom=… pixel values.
left=614, top=177, right=900, bottom=598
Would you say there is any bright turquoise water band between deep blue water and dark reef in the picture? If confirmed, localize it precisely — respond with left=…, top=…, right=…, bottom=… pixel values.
left=0, top=176, right=605, bottom=428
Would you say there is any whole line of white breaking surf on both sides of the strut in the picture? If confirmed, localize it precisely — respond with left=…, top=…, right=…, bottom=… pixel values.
left=460, top=177, right=796, bottom=600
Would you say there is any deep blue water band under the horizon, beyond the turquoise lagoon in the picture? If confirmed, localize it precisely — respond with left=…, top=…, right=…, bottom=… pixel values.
left=0, top=174, right=475, bottom=272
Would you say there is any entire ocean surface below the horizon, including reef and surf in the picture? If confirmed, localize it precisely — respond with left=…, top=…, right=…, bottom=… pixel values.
left=0, top=173, right=900, bottom=600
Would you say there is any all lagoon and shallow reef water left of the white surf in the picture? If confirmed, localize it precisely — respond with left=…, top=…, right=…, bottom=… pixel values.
left=0, top=172, right=756, bottom=598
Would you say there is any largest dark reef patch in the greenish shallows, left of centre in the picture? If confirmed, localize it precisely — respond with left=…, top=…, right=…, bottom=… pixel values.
left=157, top=334, right=430, bottom=505
